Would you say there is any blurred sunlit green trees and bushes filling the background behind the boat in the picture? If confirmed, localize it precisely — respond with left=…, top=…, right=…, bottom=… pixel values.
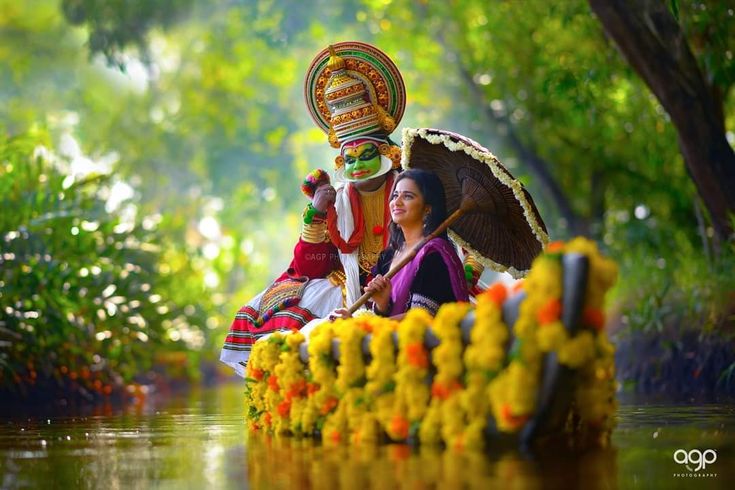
left=0, top=0, right=735, bottom=393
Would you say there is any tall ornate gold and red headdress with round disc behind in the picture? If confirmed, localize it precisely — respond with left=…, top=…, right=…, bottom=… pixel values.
left=304, top=41, right=406, bottom=180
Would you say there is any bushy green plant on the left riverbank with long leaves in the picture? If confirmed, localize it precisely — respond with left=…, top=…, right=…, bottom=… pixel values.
left=0, top=136, right=211, bottom=391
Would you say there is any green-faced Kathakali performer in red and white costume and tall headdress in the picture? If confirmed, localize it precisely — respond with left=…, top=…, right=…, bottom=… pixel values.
left=220, top=42, right=406, bottom=375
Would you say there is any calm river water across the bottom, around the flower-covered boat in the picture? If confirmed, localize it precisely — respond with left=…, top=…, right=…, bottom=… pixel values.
left=0, top=384, right=735, bottom=490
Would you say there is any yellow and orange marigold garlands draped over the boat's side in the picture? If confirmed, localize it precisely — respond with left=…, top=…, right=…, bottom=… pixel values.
left=246, top=239, right=617, bottom=449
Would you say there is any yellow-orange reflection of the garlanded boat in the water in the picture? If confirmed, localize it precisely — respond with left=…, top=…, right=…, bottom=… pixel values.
left=247, top=434, right=617, bottom=490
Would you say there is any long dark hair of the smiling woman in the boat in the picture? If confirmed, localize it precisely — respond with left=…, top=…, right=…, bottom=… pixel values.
left=388, top=168, right=447, bottom=250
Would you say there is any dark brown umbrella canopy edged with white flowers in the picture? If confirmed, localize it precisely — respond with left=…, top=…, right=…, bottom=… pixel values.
left=401, top=128, right=549, bottom=278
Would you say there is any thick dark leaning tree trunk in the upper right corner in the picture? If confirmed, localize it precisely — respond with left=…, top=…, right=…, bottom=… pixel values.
left=589, top=0, right=735, bottom=239
